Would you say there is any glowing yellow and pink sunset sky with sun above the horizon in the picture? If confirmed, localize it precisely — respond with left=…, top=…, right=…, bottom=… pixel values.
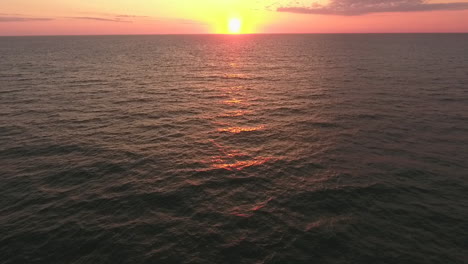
left=0, top=0, right=468, bottom=36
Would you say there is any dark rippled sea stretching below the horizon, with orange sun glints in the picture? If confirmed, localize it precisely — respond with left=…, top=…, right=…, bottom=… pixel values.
left=0, top=34, right=468, bottom=264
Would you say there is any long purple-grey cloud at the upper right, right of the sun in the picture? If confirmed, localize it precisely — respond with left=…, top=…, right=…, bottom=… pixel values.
left=276, top=0, right=468, bottom=16
